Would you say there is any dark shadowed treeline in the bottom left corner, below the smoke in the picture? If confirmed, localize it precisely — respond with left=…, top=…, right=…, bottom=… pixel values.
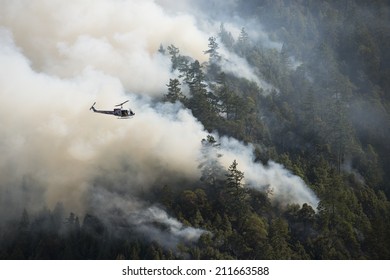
left=0, top=208, right=177, bottom=260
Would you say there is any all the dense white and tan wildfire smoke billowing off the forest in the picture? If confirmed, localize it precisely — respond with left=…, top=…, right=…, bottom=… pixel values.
left=0, top=0, right=318, bottom=246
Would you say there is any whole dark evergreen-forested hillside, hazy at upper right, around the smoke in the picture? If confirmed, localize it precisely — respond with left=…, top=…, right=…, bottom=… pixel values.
left=0, top=0, right=390, bottom=259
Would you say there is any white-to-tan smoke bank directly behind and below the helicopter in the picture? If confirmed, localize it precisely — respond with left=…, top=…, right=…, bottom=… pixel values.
left=0, top=25, right=205, bottom=228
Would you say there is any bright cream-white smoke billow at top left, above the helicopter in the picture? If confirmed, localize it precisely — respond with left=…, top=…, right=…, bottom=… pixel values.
left=0, top=0, right=208, bottom=95
